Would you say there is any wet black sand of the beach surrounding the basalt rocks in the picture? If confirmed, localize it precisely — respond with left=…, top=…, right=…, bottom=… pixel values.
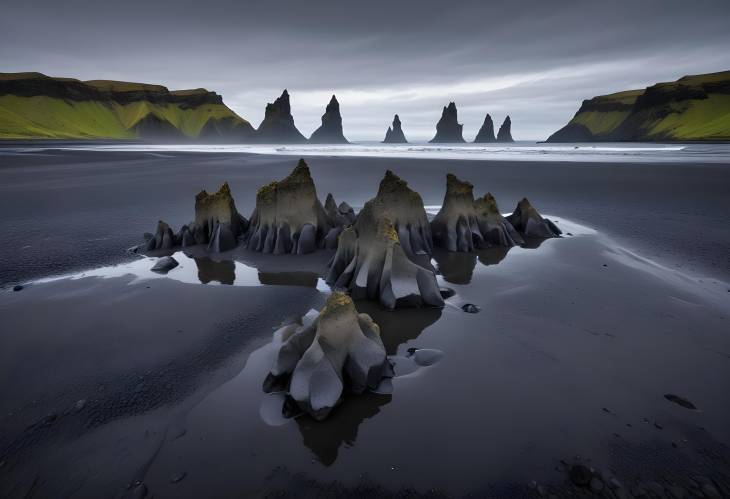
left=0, top=149, right=730, bottom=498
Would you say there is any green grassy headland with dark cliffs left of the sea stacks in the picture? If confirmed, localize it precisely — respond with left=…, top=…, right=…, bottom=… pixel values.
left=0, top=73, right=254, bottom=142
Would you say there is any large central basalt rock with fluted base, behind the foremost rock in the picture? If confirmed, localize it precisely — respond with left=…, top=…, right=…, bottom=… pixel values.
left=326, top=171, right=444, bottom=309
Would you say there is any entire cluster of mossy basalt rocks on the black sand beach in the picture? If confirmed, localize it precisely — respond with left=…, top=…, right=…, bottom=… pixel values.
left=138, top=159, right=560, bottom=419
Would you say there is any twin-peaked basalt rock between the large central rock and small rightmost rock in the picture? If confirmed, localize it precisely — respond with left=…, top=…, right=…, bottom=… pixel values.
left=431, top=173, right=522, bottom=252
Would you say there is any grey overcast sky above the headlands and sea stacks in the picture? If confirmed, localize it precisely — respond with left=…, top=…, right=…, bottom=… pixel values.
left=0, top=0, right=730, bottom=140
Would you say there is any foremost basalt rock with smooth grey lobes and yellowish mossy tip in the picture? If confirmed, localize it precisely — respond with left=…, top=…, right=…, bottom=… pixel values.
left=264, top=292, right=386, bottom=420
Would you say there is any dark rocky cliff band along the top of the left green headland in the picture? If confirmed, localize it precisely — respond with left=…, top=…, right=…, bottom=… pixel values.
left=0, top=73, right=223, bottom=108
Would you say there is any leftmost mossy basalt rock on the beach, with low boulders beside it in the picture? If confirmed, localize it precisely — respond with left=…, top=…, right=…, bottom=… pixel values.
left=146, top=182, right=248, bottom=253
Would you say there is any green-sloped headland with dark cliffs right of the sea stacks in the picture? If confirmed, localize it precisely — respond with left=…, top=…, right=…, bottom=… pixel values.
left=547, top=71, right=730, bottom=142
